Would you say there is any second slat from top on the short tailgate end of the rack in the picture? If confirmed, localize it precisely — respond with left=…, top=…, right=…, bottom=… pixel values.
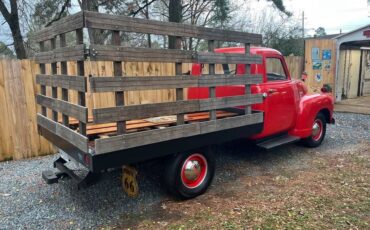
left=35, top=44, right=85, bottom=63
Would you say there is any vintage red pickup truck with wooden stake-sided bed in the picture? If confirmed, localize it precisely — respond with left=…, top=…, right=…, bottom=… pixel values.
left=33, top=11, right=334, bottom=198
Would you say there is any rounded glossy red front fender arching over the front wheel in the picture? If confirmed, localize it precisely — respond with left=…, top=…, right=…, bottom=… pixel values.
left=289, top=94, right=334, bottom=138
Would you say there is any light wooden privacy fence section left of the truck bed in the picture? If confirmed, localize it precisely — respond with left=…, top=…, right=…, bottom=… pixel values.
left=0, top=59, right=53, bottom=161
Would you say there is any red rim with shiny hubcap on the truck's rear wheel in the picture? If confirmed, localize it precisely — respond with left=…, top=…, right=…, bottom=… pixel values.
left=181, top=153, right=208, bottom=189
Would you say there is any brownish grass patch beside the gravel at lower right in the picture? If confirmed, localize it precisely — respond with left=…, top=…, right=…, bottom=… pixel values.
left=115, top=146, right=370, bottom=229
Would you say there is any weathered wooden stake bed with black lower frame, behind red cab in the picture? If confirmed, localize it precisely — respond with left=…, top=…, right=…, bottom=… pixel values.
left=33, top=11, right=263, bottom=171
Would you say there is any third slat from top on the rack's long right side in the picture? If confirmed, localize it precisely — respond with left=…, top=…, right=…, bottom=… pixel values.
left=89, top=74, right=262, bottom=92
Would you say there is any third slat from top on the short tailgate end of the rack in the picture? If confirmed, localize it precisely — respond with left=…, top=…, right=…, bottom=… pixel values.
left=36, top=74, right=87, bottom=92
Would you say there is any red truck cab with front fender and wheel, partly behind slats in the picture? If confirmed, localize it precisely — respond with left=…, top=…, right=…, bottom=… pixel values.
left=188, top=47, right=334, bottom=147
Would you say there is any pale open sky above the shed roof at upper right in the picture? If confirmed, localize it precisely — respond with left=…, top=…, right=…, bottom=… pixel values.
left=252, top=0, right=370, bottom=35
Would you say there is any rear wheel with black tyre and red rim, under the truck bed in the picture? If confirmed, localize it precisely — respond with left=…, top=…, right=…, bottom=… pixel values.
left=165, top=150, right=215, bottom=199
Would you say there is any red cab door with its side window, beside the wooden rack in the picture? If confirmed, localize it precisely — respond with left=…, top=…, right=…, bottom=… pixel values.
left=254, top=55, right=296, bottom=138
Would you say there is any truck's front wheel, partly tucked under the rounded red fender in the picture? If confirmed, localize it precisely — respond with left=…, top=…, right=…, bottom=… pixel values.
left=302, top=113, right=326, bottom=148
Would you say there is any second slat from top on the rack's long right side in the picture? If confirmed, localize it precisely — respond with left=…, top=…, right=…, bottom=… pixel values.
left=90, top=44, right=262, bottom=64
